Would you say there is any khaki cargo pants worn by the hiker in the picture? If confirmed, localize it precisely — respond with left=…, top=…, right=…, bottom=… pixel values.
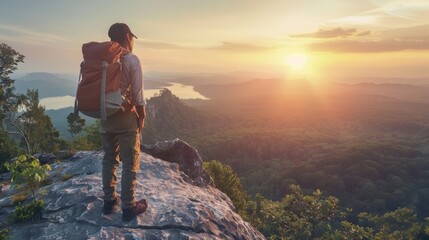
left=100, top=111, right=140, bottom=209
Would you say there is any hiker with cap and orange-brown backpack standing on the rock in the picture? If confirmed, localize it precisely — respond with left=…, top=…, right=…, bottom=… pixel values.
left=75, top=23, right=147, bottom=221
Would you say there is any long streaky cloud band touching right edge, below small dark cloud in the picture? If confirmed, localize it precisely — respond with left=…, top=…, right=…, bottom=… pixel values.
left=308, top=36, right=429, bottom=53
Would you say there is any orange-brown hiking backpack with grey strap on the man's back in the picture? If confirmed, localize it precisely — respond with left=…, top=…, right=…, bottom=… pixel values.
left=75, top=42, right=128, bottom=120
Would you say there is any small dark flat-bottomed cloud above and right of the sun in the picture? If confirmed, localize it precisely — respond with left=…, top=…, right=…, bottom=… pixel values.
left=291, top=27, right=371, bottom=38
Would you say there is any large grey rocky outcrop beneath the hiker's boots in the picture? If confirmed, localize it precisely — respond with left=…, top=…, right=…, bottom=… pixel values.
left=0, top=140, right=264, bottom=240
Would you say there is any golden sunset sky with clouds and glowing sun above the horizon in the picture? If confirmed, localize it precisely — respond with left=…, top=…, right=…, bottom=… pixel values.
left=0, top=0, right=429, bottom=79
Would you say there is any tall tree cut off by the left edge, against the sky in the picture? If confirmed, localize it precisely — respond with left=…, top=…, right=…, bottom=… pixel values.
left=0, top=43, right=24, bottom=125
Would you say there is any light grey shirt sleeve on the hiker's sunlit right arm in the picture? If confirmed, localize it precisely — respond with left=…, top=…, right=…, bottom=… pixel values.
left=130, top=55, right=146, bottom=106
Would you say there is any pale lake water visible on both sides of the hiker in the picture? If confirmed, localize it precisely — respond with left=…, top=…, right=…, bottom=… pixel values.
left=40, top=82, right=208, bottom=110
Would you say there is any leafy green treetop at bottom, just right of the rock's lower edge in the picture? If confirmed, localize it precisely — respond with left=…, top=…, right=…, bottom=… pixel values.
left=251, top=185, right=342, bottom=240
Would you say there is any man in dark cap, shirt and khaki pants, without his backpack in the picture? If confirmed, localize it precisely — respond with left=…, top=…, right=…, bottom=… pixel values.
left=101, top=23, right=147, bottom=221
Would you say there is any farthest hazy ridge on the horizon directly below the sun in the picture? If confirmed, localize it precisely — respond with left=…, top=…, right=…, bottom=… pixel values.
left=195, top=79, right=429, bottom=103
